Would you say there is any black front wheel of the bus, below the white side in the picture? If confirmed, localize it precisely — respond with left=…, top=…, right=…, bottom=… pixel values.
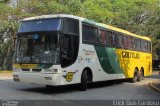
left=80, top=70, right=87, bottom=91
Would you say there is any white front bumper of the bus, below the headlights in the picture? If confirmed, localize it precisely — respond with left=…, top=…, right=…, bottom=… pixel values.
left=13, top=72, right=61, bottom=86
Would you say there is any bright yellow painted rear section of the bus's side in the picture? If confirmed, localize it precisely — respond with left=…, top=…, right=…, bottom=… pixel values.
left=116, top=49, right=152, bottom=78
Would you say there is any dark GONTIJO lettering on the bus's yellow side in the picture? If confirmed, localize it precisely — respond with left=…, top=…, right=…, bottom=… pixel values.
left=122, top=51, right=140, bottom=59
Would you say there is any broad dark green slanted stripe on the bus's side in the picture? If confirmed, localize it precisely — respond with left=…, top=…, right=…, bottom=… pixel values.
left=94, top=46, right=123, bottom=74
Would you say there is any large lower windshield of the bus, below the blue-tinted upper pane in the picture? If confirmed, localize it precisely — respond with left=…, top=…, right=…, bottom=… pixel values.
left=15, top=32, right=59, bottom=64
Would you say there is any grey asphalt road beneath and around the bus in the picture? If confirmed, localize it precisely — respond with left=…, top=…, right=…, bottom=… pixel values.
left=0, top=76, right=160, bottom=106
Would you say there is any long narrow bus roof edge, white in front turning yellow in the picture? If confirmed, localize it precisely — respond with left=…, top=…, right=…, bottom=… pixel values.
left=22, top=14, right=151, bottom=41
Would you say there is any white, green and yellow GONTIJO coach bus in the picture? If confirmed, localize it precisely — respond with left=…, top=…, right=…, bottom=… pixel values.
left=13, top=14, right=152, bottom=91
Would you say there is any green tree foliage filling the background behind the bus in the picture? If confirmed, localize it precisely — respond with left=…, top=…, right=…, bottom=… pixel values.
left=0, top=0, right=160, bottom=69
